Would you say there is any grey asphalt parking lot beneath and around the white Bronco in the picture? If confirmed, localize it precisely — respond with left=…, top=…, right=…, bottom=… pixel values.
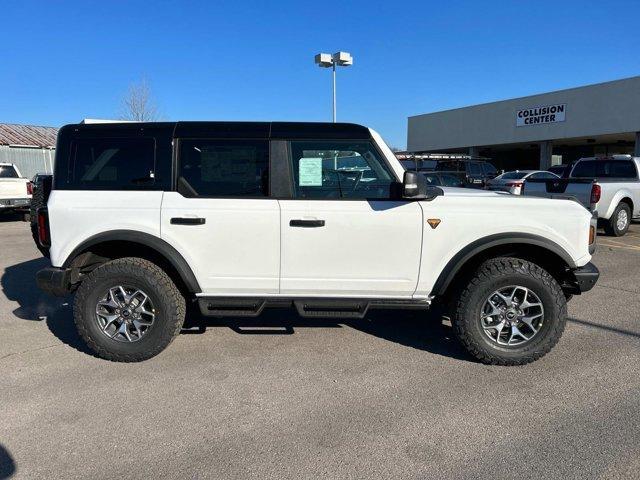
left=0, top=218, right=640, bottom=479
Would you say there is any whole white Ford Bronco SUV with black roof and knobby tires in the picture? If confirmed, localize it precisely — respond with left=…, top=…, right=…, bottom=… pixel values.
left=37, top=122, right=598, bottom=365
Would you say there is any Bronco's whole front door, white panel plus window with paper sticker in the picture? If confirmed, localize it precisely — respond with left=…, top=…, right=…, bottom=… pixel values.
left=280, top=140, right=422, bottom=298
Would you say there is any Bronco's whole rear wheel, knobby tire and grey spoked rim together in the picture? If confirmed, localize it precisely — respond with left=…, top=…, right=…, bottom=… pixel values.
left=73, top=258, right=185, bottom=362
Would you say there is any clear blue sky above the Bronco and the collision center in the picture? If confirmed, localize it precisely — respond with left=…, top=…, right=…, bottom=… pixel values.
left=0, top=0, right=640, bottom=147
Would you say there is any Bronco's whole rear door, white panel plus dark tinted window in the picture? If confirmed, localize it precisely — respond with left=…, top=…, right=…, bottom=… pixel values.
left=161, top=138, right=280, bottom=296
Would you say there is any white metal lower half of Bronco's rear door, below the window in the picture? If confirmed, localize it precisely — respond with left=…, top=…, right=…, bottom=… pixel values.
left=161, top=192, right=280, bottom=295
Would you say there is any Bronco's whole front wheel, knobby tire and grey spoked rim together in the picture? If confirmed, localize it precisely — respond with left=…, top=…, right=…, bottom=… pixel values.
left=451, top=257, right=567, bottom=365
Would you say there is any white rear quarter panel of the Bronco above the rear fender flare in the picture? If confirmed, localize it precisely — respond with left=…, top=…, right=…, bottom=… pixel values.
left=47, top=190, right=163, bottom=267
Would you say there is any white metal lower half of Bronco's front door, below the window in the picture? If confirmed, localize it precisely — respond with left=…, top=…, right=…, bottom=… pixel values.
left=280, top=200, right=423, bottom=297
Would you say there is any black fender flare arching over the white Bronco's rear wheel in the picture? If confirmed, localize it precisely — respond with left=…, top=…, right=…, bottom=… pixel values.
left=62, top=230, right=202, bottom=293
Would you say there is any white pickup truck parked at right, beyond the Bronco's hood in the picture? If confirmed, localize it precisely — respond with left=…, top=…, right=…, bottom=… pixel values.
left=524, top=155, right=640, bottom=237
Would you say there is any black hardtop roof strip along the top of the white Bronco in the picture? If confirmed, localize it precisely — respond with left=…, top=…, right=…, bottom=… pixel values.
left=60, top=121, right=371, bottom=140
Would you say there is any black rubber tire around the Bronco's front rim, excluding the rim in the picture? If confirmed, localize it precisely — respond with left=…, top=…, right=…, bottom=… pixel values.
left=450, top=257, right=567, bottom=365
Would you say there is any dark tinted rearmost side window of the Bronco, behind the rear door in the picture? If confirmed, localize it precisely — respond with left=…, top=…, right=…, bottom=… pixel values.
left=67, top=138, right=155, bottom=190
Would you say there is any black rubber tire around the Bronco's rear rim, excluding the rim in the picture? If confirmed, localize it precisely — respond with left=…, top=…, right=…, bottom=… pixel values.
left=73, top=257, right=186, bottom=362
